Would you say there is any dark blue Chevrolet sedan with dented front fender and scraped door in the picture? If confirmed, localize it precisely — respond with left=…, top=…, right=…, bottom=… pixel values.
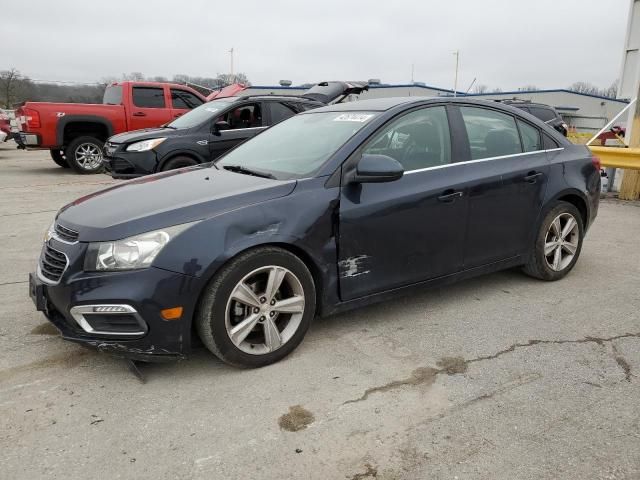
left=30, top=97, right=600, bottom=367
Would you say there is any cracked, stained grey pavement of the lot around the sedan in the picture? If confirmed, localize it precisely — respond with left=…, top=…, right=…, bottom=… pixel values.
left=0, top=144, right=640, bottom=480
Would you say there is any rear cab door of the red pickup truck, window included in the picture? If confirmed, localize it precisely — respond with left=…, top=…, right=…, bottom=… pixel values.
left=129, top=85, right=171, bottom=130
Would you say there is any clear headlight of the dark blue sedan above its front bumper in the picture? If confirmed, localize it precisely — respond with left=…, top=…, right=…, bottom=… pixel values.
left=84, top=223, right=193, bottom=271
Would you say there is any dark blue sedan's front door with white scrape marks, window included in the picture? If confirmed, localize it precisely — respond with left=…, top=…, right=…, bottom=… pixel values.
left=338, top=106, right=467, bottom=300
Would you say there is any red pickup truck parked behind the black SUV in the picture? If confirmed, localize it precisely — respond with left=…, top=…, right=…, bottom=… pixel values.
left=15, top=82, right=206, bottom=173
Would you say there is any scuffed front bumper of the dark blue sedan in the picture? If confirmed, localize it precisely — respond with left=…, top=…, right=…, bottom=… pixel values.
left=29, top=239, right=201, bottom=361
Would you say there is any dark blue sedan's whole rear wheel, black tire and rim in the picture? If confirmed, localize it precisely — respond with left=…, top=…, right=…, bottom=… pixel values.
left=523, top=202, right=584, bottom=282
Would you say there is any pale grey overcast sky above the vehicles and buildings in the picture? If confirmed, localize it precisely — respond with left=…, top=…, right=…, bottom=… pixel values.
left=0, top=0, right=629, bottom=90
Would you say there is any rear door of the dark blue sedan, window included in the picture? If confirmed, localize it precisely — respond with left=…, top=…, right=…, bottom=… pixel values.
left=459, top=106, right=549, bottom=268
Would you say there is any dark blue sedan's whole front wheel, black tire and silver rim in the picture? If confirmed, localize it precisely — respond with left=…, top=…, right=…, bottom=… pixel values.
left=195, top=247, right=316, bottom=368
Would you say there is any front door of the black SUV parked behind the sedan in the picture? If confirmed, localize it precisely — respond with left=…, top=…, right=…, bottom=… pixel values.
left=209, top=101, right=266, bottom=160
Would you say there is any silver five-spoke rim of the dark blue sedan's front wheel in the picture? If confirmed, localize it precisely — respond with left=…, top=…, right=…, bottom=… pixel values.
left=225, top=265, right=305, bottom=355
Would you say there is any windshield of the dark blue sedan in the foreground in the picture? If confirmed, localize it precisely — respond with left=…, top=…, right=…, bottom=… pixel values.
left=216, top=112, right=377, bottom=180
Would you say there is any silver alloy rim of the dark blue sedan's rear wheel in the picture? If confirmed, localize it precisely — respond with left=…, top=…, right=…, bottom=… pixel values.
left=544, top=213, right=580, bottom=272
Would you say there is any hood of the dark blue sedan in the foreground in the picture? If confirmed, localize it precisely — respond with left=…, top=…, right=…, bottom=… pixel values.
left=57, top=166, right=296, bottom=242
